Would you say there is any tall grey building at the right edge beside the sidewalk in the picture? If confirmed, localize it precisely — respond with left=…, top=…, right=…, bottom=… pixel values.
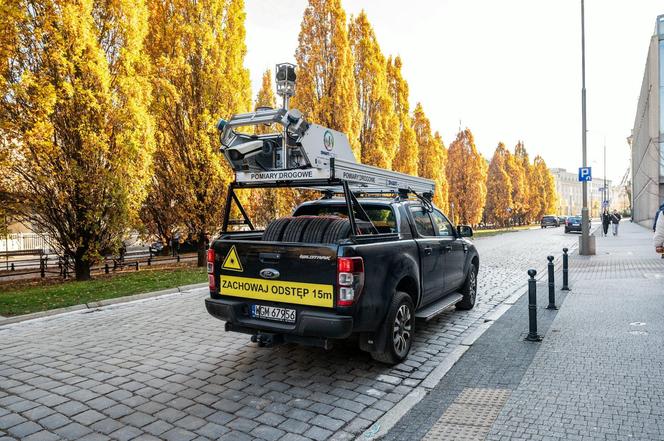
left=627, top=15, right=664, bottom=226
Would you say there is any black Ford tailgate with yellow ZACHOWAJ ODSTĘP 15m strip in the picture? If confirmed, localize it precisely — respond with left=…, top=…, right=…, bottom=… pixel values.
left=213, top=240, right=337, bottom=308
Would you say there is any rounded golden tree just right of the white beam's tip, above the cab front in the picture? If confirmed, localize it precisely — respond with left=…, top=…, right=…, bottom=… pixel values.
left=446, top=128, right=486, bottom=225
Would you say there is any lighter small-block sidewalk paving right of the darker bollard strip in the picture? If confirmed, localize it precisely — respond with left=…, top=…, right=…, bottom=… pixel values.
left=487, top=222, right=664, bottom=441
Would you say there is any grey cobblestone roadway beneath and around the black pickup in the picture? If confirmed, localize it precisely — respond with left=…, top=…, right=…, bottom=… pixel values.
left=0, top=228, right=578, bottom=441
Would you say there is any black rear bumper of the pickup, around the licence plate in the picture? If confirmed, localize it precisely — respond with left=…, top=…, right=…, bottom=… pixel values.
left=205, top=298, right=353, bottom=338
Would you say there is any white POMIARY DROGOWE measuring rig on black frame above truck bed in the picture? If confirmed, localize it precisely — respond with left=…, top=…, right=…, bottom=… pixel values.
left=220, top=113, right=435, bottom=239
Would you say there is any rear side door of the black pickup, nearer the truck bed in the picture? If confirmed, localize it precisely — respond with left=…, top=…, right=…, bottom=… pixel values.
left=410, top=206, right=444, bottom=305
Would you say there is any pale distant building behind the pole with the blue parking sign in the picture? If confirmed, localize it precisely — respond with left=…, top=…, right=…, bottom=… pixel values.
left=550, top=168, right=613, bottom=217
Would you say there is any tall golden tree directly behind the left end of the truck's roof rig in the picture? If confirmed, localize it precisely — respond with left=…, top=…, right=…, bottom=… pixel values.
left=146, top=0, right=251, bottom=266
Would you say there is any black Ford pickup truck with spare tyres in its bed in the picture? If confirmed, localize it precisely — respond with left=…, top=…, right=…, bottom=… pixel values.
left=205, top=197, right=479, bottom=364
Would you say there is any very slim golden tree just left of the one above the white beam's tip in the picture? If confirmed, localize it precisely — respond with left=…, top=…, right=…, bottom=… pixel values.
left=387, top=57, right=418, bottom=175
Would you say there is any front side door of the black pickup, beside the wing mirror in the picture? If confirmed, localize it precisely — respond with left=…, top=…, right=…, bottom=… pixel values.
left=431, top=210, right=467, bottom=293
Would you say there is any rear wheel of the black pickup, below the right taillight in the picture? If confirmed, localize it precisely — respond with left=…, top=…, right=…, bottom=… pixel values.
left=371, top=291, right=415, bottom=364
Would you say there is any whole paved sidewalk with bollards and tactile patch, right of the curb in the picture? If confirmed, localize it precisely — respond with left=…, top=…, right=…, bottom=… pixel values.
left=385, top=222, right=664, bottom=441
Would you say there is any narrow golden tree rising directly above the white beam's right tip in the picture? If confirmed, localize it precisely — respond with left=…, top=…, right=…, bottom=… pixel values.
left=412, top=103, right=448, bottom=212
